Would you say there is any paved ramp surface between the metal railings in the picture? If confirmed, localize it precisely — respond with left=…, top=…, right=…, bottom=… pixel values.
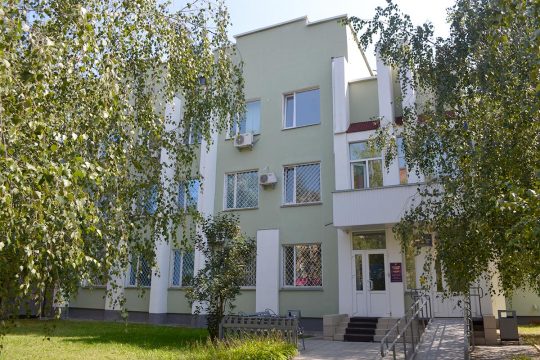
left=416, top=319, right=465, bottom=360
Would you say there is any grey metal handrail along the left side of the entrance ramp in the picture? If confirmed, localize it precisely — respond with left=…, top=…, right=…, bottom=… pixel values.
left=381, top=290, right=433, bottom=359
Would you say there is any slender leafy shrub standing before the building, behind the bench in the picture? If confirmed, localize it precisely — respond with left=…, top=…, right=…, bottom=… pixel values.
left=186, top=214, right=255, bottom=340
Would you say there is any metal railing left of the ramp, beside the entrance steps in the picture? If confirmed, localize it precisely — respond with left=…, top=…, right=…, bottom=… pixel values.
left=381, top=290, right=433, bottom=359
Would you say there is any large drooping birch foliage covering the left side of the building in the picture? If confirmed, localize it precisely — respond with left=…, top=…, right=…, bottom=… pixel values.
left=0, top=0, right=244, bottom=318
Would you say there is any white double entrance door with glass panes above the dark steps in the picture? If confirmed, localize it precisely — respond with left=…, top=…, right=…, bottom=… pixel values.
left=353, top=250, right=389, bottom=316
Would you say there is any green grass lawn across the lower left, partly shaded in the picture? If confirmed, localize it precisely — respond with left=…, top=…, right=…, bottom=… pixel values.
left=0, top=320, right=296, bottom=360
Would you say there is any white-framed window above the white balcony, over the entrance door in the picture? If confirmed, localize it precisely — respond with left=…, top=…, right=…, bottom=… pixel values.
left=349, top=142, right=383, bottom=189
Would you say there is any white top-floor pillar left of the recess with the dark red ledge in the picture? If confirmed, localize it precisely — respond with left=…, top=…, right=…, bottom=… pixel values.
left=332, top=57, right=349, bottom=134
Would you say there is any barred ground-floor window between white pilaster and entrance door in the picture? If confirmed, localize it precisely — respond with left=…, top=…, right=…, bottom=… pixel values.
left=283, top=244, right=322, bottom=287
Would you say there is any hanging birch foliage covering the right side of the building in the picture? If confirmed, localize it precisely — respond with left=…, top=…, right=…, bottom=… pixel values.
left=349, top=0, right=540, bottom=294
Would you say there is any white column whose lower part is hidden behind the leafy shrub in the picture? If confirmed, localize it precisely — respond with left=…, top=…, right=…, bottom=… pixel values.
left=191, top=127, right=218, bottom=313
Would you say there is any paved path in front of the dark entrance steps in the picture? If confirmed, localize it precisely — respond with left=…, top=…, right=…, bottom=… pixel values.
left=295, top=339, right=379, bottom=360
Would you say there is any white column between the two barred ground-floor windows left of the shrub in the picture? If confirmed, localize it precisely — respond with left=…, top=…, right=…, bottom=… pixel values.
left=148, top=97, right=182, bottom=314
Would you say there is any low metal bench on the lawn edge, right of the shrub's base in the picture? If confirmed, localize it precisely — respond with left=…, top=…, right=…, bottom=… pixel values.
left=219, top=313, right=298, bottom=345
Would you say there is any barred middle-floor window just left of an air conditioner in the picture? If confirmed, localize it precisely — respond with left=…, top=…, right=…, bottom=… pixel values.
left=225, top=171, right=259, bottom=209
